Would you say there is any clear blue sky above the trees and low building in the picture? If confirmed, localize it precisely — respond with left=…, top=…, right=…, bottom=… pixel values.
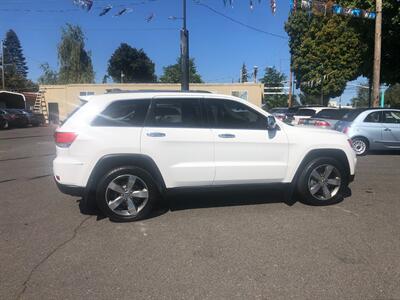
left=0, top=0, right=360, bottom=102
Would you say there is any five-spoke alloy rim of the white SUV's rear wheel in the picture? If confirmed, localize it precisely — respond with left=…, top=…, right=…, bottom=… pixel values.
left=105, top=174, right=149, bottom=216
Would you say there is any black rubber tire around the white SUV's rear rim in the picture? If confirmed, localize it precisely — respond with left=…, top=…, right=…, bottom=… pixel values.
left=96, top=166, right=159, bottom=222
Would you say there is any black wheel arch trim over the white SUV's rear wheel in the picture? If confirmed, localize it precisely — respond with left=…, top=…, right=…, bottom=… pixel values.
left=87, top=153, right=166, bottom=194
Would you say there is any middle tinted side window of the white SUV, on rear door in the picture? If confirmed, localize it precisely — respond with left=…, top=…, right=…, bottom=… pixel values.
left=146, top=99, right=203, bottom=128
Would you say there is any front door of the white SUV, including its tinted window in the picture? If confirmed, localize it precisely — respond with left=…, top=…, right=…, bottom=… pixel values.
left=204, top=99, right=288, bottom=185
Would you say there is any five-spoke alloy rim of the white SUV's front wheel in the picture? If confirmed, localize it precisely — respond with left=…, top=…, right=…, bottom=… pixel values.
left=308, top=165, right=341, bottom=200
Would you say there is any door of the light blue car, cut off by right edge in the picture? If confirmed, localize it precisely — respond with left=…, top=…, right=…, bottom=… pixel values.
left=382, top=110, right=400, bottom=148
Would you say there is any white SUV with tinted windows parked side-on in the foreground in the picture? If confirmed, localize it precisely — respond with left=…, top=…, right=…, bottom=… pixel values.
left=53, top=92, right=356, bottom=221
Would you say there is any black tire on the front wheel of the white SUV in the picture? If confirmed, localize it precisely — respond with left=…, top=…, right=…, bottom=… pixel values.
left=296, top=157, right=348, bottom=205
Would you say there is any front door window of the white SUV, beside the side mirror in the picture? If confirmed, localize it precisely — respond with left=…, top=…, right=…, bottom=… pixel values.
left=205, top=99, right=266, bottom=130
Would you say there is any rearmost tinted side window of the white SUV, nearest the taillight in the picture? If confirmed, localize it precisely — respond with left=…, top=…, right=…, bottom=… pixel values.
left=92, top=100, right=150, bottom=127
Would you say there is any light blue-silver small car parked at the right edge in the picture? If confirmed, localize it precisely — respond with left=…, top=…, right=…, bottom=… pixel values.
left=335, top=108, right=400, bottom=155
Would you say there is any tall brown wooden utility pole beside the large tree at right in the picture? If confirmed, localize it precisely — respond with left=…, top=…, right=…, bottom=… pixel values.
left=373, top=0, right=382, bottom=107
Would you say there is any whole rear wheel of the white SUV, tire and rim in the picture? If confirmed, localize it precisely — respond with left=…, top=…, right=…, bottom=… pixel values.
left=96, top=166, right=158, bottom=221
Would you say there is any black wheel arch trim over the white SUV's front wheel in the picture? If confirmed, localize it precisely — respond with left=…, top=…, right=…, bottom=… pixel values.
left=292, top=149, right=350, bottom=186
